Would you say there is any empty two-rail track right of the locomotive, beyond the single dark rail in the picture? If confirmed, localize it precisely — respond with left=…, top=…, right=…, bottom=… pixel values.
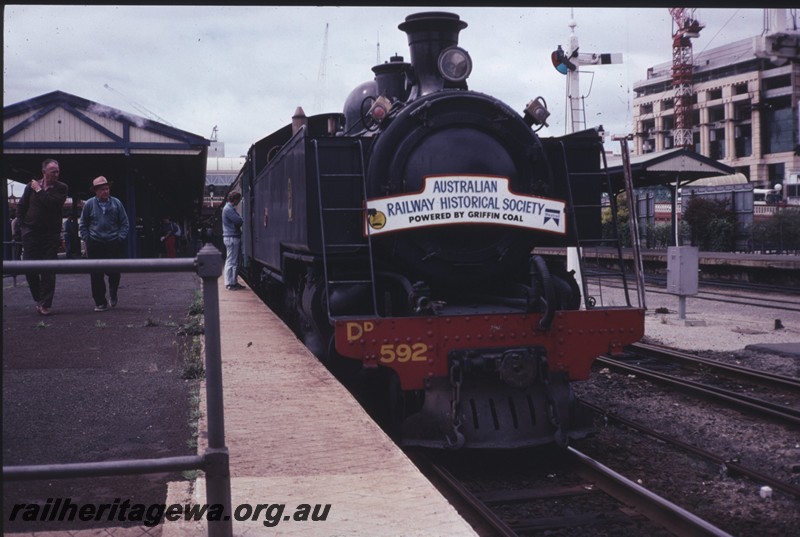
left=597, top=343, right=800, bottom=426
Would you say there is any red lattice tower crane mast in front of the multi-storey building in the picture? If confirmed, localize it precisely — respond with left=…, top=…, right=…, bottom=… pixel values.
left=669, top=7, right=704, bottom=147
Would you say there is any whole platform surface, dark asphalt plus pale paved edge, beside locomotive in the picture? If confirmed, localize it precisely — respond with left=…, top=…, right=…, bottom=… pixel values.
left=4, top=274, right=477, bottom=537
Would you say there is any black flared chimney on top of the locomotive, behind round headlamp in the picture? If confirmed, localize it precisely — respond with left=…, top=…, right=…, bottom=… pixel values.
left=398, top=11, right=467, bottom=100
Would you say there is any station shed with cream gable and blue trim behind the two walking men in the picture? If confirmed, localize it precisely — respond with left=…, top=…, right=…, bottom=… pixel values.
left=3, top=91, right=210, bottom=257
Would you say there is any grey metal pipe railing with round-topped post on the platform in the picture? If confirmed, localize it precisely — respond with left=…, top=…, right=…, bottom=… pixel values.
left=3, top=244, right=233, bottom=537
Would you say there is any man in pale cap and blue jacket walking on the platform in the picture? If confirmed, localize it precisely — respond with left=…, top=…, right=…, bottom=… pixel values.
left=78, top=175, right=130, bottom=311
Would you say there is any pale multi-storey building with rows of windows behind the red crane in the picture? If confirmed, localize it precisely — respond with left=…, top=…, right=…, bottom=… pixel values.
left=633, top=10, right=800, bottom=204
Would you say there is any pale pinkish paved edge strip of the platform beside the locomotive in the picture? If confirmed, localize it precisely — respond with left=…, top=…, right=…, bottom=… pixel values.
left=163, top=279, right=477, bottom=537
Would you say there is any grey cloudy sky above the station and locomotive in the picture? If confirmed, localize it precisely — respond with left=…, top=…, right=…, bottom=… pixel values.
left=3, top=4, right=763, bottom=156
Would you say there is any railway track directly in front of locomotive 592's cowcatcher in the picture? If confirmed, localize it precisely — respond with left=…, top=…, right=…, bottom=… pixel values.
left=409, top=447, right=729, bottom=537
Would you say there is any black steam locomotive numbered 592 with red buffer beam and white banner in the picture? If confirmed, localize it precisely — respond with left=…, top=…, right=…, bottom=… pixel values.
left=233, top=12, right=644, bottom=448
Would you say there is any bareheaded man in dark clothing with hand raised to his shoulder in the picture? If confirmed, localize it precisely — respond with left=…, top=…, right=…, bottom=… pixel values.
left=17, top=159, right=69, bottom=315
